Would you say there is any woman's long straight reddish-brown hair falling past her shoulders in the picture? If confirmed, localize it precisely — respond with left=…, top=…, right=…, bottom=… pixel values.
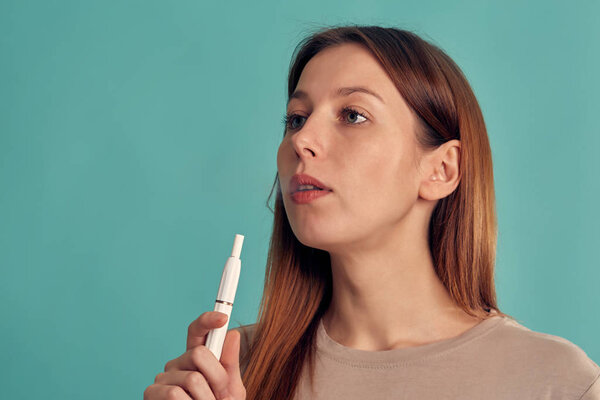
left=242, top=25, right=512, bottom=400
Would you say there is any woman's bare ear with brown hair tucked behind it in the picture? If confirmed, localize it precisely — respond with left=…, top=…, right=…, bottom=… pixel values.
left=419, top=139, right=460, bottom=200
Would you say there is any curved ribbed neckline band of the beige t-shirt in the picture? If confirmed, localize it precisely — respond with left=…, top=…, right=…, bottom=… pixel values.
left=317, top=315, right=506, bottom=367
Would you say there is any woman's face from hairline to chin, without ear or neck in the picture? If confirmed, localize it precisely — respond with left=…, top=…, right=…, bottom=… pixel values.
left=277, top=44, right=421, bottom=251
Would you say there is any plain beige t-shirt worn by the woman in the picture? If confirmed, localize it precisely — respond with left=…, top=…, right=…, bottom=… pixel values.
left=238, top=316, right=600, bottom=400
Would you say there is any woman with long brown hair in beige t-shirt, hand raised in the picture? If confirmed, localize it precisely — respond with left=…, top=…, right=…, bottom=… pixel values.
left=145, top=26, right=600, bottom=400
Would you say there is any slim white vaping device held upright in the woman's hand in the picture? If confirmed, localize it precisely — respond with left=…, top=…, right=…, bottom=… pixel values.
left=206, top=234, right=244, bottom=360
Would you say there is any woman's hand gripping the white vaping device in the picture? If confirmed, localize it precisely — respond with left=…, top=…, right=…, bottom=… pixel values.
left=144, top=311, right=246, bottom=400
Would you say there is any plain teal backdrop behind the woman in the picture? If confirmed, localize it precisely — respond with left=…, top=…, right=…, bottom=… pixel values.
left=0, top=0, right=600, bottom=399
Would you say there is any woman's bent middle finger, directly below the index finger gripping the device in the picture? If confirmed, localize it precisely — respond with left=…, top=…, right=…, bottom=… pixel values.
left=165, top=345, right=229, bottom=399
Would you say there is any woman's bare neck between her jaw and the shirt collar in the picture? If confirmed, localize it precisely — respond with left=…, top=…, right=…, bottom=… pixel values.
left=323, top=241, right=481, bottom=350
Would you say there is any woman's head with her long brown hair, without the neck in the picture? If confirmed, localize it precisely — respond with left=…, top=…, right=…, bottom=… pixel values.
left=242, top=26, right=510, bottom=399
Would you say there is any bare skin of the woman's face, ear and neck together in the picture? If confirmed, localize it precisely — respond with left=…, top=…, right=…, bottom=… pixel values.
left=277, top=43, right=488, bottom=350
